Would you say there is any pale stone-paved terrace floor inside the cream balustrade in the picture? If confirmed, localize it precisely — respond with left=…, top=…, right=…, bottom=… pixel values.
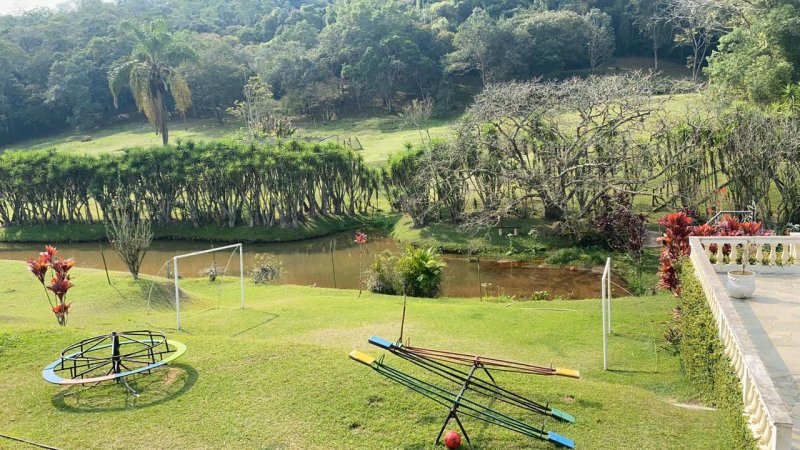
left=720, top=274, right=800, bottom=450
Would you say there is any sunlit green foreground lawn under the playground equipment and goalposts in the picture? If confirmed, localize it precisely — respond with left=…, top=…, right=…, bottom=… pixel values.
left=0, top=261, right=730, bottom=449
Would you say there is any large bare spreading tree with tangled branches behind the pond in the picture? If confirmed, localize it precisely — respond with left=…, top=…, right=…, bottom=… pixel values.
left=457, top=73, right=671, bottom=232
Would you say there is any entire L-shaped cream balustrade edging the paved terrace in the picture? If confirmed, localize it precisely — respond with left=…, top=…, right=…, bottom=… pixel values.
left=689, top=236, right=800, bottom=450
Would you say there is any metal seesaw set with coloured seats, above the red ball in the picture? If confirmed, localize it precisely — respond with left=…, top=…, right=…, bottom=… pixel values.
left=350, top=336, right=580, bottom=448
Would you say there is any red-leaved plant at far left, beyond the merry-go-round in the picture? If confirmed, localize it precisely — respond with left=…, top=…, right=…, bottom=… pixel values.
left=27, top=245, right=75, bottom=326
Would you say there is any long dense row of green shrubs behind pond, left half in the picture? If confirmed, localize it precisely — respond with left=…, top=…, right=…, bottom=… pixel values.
left=0, top=142, right=378, bottom=227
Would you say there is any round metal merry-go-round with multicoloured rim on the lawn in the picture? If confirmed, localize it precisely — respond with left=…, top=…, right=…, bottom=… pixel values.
left=42, top=330, right=186, bottom=397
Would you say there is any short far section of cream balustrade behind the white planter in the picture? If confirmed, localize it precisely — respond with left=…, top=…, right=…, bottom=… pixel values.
left=692, top=236, right=800, bottom=273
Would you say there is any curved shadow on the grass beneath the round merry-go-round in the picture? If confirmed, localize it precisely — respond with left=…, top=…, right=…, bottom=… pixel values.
left=52, top=364, right=198, bottom=413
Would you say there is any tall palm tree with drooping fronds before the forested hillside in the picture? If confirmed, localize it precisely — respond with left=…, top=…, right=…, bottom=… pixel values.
left=108, top=19, right=197, bottom=145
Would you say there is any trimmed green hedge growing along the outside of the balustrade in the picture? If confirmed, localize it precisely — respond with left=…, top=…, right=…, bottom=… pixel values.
left=678, top=259, right=756, bottom=449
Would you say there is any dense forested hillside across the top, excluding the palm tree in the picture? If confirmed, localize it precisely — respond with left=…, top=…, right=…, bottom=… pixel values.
left=0, top=0, right=800, bottom=145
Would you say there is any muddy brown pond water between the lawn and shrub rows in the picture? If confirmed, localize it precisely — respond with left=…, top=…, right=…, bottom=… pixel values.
left=0, top=234, right=616, bottom=299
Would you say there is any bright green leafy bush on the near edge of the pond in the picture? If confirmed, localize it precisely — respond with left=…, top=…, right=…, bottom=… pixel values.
left=397, top=246, right=446, bottom=297
